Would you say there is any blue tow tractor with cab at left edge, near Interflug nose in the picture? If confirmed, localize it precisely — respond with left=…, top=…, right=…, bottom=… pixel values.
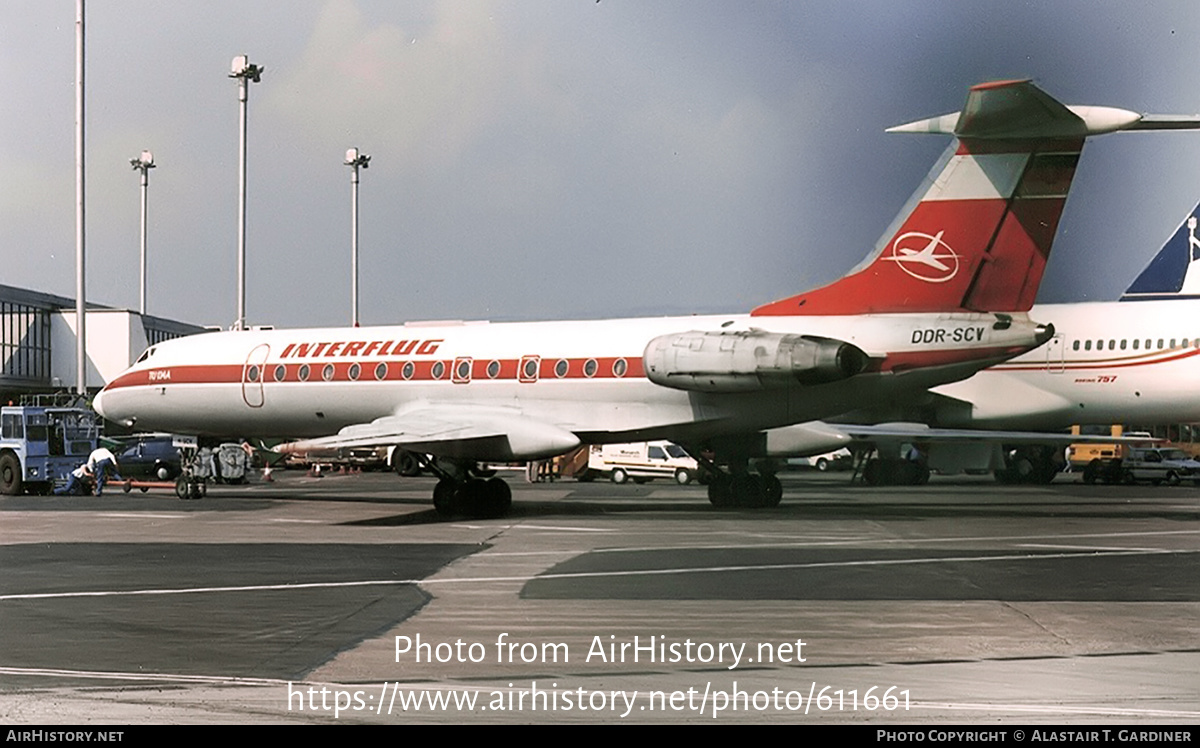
left=0, top=395, right=100, bottom=496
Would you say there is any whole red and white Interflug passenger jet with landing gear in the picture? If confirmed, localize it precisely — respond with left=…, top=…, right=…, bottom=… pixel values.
left=95, top=80, right=1190, bottom=515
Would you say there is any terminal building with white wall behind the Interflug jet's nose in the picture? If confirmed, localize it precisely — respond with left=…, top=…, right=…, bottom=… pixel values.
left=0, top=285, right=209, bottom=403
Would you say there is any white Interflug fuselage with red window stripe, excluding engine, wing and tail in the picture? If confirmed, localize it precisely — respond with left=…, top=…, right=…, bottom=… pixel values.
left=96, top=313, right=1045, bottom=451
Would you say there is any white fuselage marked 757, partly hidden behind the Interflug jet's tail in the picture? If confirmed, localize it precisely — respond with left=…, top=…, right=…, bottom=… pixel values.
left=934, top=299, right=1200, bottom=429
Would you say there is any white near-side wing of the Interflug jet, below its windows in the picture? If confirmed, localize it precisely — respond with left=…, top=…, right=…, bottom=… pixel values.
left=280, top=403, right=580, bottom=462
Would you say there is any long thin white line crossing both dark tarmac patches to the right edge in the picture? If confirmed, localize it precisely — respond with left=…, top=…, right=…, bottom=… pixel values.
left=0, top=550, right=1185, bottom=602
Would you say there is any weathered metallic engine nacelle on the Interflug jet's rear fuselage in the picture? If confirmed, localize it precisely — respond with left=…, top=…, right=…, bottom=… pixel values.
left=642, top=330, right=870, bottom=393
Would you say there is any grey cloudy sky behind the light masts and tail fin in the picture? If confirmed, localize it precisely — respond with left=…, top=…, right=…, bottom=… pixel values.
left=0, top=0, right=1200, bottom=327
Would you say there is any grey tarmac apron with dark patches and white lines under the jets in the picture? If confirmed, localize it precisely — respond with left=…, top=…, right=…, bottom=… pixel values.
left=0, top=472, right=1200, bottom=725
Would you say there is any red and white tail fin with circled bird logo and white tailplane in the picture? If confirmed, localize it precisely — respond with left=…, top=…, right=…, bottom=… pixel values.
left=752, top=80, right=1200, bottom=315
